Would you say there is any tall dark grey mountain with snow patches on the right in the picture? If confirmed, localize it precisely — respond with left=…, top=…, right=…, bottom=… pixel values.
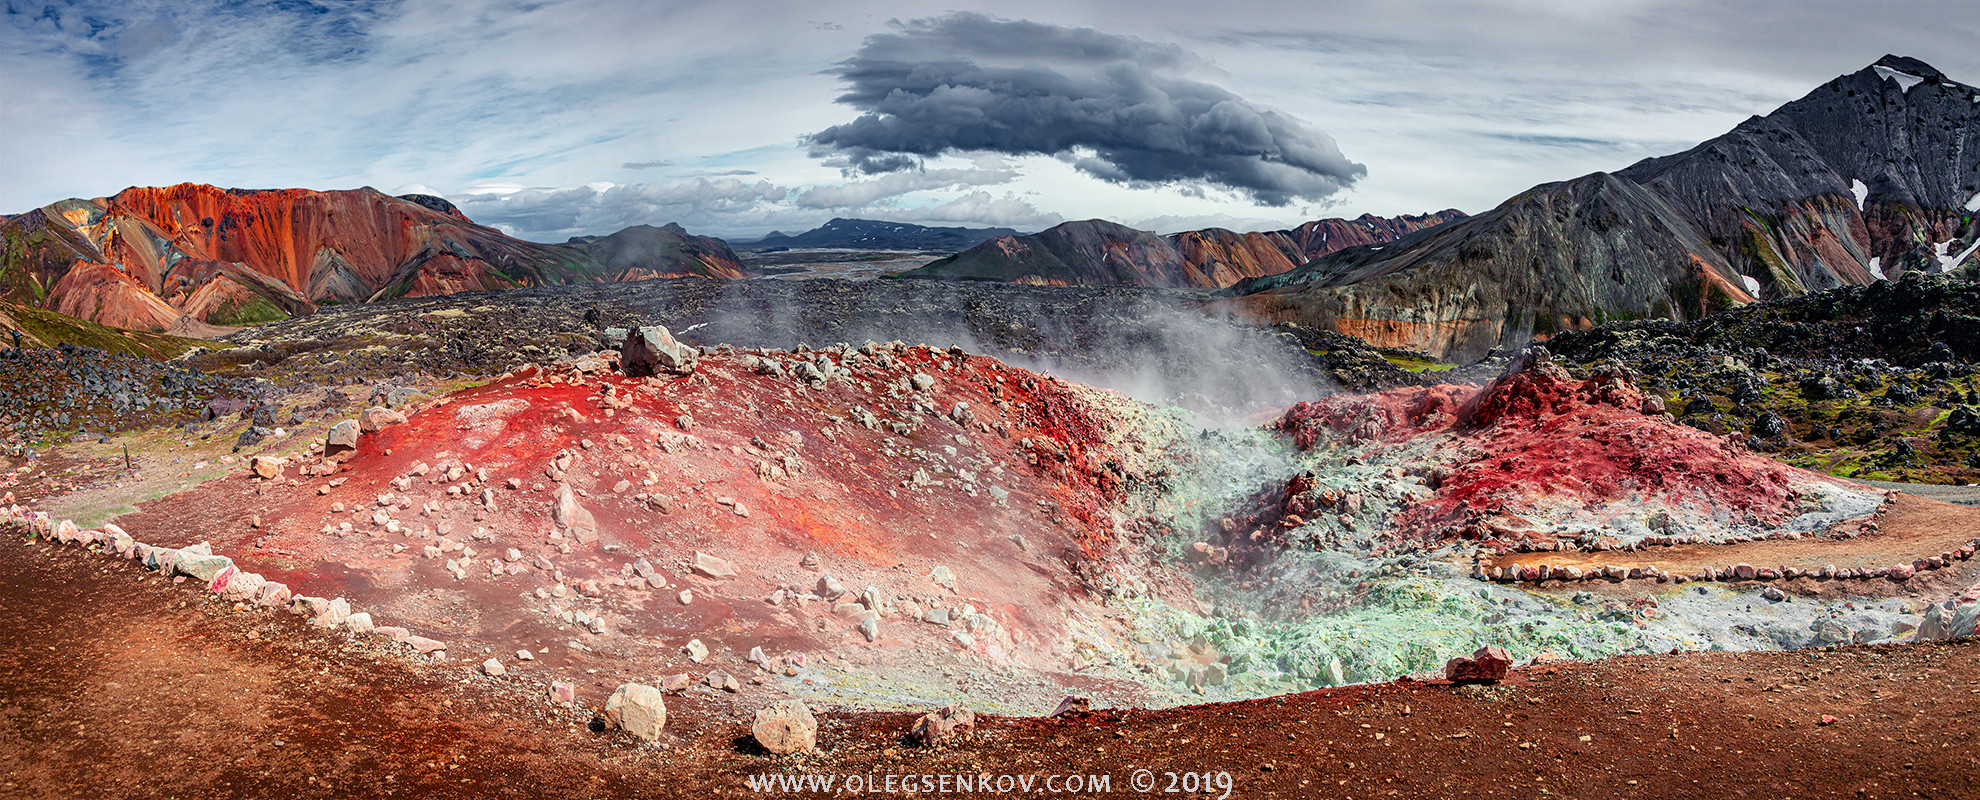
left=1214, top=55, right=1980, bottom=360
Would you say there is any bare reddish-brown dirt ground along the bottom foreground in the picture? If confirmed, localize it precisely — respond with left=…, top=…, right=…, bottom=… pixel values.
left=0, top=537, right=1980, bottom=798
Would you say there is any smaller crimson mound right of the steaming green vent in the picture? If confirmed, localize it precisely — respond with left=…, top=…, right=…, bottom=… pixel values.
left=1275, top=360, right=1875, bottom=545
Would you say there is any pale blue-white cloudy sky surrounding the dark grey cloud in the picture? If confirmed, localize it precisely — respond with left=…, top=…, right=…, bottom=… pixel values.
left=0, top=0, right=1980, bottom=236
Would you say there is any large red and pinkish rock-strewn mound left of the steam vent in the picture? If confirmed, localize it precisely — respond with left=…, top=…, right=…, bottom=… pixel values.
left=119, top=347, right=1162, bottom=707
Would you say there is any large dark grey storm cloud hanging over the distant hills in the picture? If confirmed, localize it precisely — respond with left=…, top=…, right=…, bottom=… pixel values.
left=808, top=14, right=1368, bottom=206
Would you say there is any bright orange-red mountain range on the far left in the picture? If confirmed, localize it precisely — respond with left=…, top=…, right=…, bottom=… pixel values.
left=0, top=184, right=748, bottom=335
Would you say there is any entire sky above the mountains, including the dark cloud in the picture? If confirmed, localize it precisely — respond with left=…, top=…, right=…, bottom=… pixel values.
left=0, top=0, right=1980, bottom=242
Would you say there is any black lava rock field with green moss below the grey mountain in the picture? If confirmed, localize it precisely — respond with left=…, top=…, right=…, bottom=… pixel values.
left=1546, top=273, right=1980, bottom=483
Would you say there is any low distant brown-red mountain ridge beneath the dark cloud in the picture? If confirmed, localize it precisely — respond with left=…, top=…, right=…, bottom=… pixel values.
left=905, top=210, right=1465, bottom=289
